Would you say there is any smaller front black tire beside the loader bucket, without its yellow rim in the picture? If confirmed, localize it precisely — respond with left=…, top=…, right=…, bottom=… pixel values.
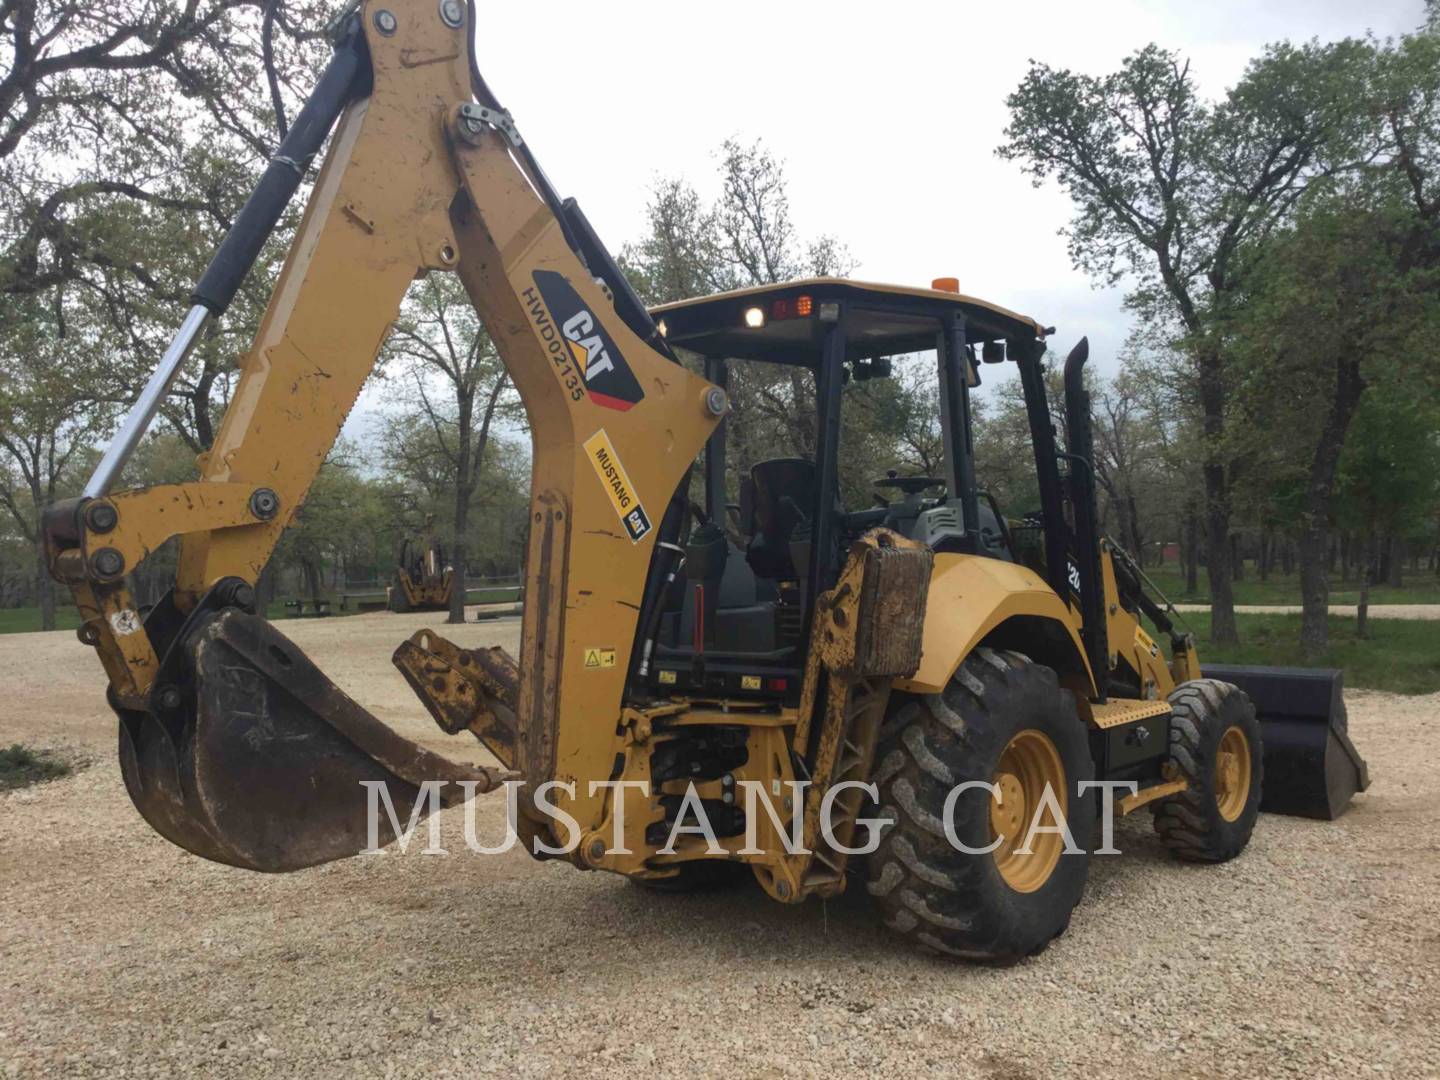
left=1153, top=678, right=1264, bottom=863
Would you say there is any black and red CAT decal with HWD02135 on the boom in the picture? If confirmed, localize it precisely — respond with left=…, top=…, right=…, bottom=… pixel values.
left=524, top=271, right=645, bottom=412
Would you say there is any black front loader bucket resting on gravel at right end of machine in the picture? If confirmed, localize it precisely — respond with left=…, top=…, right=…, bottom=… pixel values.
left=1201, top=664, right=1369, bottom=821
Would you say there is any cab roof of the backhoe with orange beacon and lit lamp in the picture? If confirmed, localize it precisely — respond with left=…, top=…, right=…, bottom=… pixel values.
left=649, top=278, right=1045, bottom=366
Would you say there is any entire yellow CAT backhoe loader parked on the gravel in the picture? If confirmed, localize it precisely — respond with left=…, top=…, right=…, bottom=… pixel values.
left=46, top=0, right=1365, bottom=962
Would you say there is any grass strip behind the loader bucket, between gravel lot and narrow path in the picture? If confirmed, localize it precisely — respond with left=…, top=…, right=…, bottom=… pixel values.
left=1185, top=612, right=1440, bottom=694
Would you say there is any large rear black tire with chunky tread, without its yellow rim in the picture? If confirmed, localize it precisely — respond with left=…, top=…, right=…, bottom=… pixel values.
left=868, top=648, right=1097, bottom=963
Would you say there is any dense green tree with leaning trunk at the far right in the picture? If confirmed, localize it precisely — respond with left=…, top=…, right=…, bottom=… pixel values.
left=1230, top=192, right=1440, bottom=657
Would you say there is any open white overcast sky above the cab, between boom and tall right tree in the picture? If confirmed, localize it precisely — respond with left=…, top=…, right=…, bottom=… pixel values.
left=342, top=0, right=1423, bottom=435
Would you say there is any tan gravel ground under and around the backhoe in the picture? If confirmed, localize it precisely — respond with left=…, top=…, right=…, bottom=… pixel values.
left=0, top=615, right=1440, bottom=1080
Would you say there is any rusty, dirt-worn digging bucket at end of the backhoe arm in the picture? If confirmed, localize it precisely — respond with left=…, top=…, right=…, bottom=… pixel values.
left=117, top=608, right=503, bottom=873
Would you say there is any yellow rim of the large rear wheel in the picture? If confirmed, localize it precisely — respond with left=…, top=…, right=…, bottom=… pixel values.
left=991, top=729, right=1070, bottom=893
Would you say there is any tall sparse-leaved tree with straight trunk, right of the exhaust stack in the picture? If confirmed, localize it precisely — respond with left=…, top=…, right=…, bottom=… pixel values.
left=998, top=42, right=1365, bottom=642
